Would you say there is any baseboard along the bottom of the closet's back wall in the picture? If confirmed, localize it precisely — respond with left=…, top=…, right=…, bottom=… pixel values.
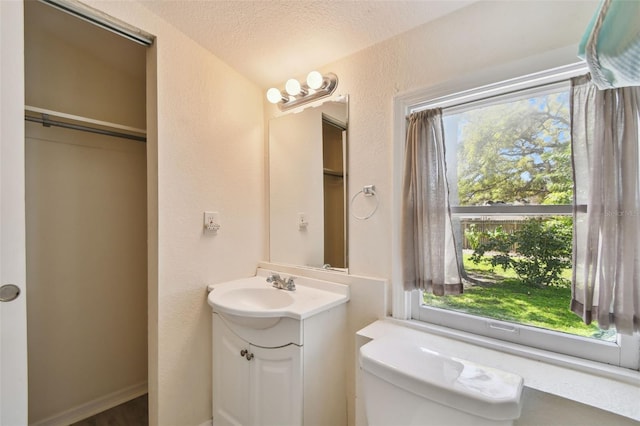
left=29, top=382, right=147, bottom=426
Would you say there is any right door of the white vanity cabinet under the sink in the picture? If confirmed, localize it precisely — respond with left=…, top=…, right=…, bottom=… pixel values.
left=249, top=345, right=303, bottom=426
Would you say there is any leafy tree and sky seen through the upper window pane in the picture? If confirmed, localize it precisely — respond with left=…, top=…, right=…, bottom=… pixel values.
left=457, top=91, right=573, bottom=206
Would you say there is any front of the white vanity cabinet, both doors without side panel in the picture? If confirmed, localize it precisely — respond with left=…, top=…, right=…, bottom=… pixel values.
left=213, top=314, right=303, bottom=426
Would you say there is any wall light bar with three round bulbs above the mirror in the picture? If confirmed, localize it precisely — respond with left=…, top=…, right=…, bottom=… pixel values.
left=267, top=71, right=338, bottom=111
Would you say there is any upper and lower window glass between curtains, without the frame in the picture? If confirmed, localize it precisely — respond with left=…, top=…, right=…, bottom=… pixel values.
left=424, top=89, right=616, bottom=341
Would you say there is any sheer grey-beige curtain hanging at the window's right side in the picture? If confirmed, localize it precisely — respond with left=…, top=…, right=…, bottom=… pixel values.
left=571, top=77, right=640, bottom=334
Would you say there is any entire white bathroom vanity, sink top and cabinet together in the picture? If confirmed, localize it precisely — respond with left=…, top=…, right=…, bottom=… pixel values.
left=207, top=268, right=349, bottom=426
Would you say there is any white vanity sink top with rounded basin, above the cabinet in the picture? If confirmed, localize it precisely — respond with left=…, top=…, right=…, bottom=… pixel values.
left=208, top=269, right=349, bottom=329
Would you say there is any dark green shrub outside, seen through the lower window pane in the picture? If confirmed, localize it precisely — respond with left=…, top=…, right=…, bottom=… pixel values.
left=471, top=217, right=572, bottom=286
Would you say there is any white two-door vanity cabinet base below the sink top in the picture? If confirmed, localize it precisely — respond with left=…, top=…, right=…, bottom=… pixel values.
left=213, top=296, right=347, bottom=426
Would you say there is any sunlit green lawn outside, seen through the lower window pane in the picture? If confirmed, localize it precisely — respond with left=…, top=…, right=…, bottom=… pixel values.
left=424, top=255, right=615, bottom=339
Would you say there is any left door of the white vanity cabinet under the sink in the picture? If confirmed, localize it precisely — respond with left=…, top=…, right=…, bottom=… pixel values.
left=213, top=315, right=252, bottom=426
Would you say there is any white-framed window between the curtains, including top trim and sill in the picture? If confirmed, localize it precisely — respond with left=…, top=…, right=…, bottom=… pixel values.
left=400, top=63, right=638, bottom=369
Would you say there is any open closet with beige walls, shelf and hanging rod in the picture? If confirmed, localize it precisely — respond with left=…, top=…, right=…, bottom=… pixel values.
left=24, top=1, right=151, bottom=425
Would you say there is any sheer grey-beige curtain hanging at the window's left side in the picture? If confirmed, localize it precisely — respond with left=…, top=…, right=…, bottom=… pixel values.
left=401, top=109, right=462, bottom=295
